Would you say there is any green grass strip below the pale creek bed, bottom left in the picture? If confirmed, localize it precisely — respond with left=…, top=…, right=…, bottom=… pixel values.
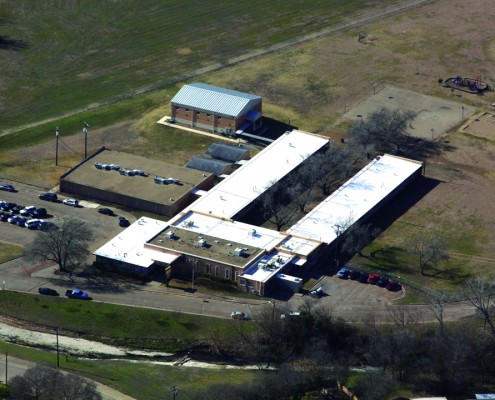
left=0, top=342, right=262, bottom=400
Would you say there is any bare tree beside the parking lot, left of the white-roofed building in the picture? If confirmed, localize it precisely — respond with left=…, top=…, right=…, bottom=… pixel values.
left=26, top=218, right=93, bottom=271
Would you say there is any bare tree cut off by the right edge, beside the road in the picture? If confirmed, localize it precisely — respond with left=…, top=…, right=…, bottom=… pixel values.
left=464, top=276, right=495, bottom=335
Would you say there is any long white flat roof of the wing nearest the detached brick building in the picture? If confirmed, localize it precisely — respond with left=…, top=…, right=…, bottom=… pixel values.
left=174, top=130, right=328, bottom=220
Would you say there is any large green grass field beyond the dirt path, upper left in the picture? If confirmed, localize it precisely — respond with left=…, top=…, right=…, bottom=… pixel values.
left=0, top=0, right=398, bottom=129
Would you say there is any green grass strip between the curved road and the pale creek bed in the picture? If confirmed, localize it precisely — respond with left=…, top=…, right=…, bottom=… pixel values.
left=0, top=290, right=254, bottom=352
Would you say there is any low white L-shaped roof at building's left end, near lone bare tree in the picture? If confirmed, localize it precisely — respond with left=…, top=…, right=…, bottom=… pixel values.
left=93, top=217, right=170, bottom=268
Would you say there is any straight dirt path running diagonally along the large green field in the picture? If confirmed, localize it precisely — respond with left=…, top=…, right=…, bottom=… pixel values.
left=0, top=0, right=433, bottom=136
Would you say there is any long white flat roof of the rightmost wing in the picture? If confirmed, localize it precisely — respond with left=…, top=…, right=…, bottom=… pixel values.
left=287, top=154, right=422, bottom=244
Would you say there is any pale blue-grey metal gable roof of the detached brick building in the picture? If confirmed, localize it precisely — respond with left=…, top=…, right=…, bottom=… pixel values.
left=171, top=83, right=261, bottom=117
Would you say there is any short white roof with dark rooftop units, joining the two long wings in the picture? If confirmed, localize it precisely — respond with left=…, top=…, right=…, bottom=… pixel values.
left=173, top=212, right=287, bottom=251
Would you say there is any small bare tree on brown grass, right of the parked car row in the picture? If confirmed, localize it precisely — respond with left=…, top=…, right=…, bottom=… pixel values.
left=408, top=233, right=447, bottom=275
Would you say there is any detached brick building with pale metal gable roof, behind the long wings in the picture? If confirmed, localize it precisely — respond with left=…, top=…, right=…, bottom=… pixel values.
left=170, top=83, right=262, bottom=135
